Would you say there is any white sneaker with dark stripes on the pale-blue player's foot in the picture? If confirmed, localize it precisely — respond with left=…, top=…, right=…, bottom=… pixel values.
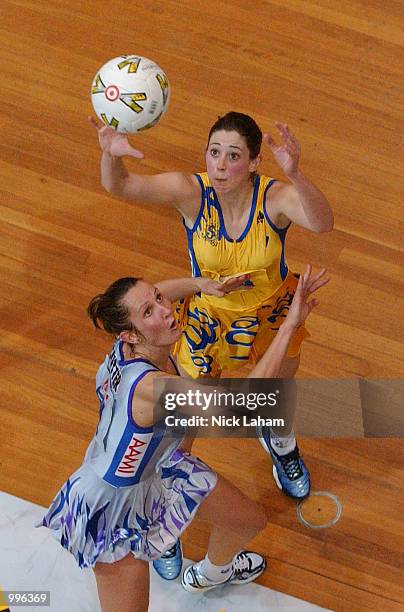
left=181, top=550, right=266, bottom=593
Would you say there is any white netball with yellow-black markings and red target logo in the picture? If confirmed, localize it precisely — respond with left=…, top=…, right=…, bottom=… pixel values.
left=91, top=55, right=170, bottom=133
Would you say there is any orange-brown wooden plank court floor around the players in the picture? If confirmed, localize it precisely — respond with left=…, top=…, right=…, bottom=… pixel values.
left=0, top=0, right=404, bottom=611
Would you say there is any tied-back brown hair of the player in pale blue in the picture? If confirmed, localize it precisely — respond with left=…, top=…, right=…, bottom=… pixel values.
left=87, top=276, right=140, bottom=334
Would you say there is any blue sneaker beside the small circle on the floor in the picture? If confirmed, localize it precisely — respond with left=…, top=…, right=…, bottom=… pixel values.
left=257, top=427, right=310, bottom=500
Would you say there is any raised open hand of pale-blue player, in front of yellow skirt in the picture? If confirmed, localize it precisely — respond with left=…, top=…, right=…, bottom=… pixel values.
left=285, top=264, right=330, bottom=327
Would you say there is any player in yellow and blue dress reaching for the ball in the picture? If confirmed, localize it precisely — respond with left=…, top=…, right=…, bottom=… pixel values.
left=91, top=112, right=333, bottom=506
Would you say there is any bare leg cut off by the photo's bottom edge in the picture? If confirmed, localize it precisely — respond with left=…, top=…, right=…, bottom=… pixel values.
left=94, top=553, right=149, bottom=612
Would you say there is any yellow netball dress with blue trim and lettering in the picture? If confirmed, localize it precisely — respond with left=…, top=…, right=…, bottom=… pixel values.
left=174, top=173, right=309, bottom=378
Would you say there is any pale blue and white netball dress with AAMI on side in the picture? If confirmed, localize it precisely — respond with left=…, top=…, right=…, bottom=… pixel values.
left=37, top=341, right=217, bottom=568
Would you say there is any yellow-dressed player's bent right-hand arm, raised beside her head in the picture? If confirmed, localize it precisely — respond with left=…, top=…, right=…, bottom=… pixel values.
left=264, top=123, right=334, bottom=232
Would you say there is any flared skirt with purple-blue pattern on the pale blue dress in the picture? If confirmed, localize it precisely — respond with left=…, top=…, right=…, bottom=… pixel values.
left=36, top=449, right=217, bottom=568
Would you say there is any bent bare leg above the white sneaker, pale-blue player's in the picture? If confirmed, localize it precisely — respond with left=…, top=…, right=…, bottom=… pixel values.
left=197, top=477, right=267, bottom=565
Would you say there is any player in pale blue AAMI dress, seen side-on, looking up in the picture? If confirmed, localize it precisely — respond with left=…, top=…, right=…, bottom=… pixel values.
left=37, top=270, right=326, bottom=612
